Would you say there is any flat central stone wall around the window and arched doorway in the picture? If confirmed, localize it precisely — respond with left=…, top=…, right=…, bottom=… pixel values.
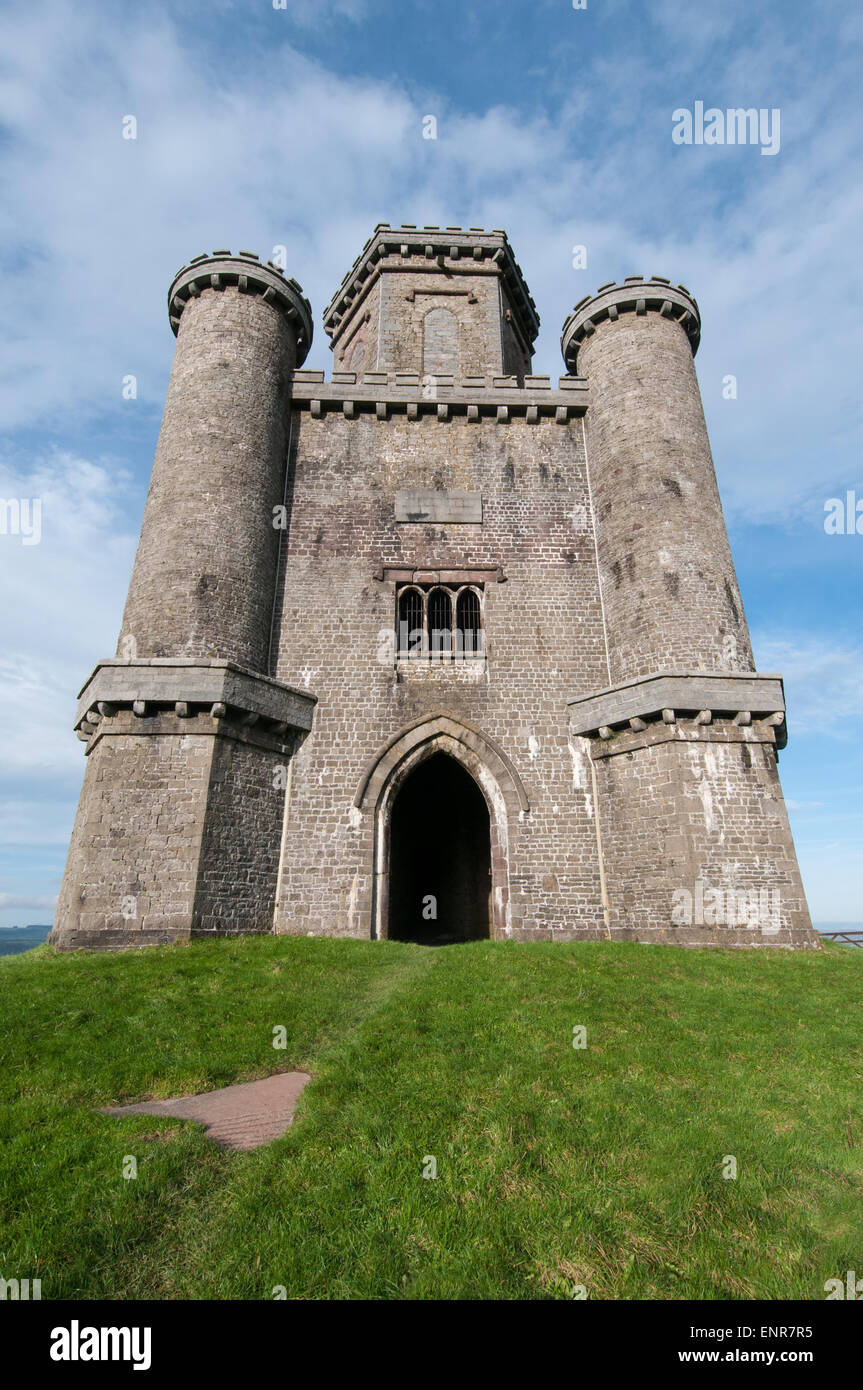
left=275, top=410, right=607, bottom=940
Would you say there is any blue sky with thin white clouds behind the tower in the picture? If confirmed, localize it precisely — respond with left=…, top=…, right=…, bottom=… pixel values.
left=0, top=0, right=863, bottom=924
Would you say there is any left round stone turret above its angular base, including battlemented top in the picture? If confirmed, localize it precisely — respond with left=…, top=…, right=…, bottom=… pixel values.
left=118, top=252, right=311, bottom=671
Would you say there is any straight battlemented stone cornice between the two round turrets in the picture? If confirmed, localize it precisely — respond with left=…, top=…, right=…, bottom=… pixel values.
left=290, top=371, right=588, bottom=424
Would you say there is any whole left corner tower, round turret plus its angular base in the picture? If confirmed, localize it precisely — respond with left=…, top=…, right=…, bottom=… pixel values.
left=51, top=252, right=314, bottom=947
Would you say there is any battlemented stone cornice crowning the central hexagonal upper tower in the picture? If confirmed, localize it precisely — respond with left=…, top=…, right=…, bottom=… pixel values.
left=324, top=222, right=539, bottom=353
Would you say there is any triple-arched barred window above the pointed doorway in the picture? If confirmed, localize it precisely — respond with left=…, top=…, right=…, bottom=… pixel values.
left=396, top=584, right=485, bottom=660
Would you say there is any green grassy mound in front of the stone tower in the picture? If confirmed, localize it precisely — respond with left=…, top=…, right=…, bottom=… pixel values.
left=0, top=937, right=863, bottom=1300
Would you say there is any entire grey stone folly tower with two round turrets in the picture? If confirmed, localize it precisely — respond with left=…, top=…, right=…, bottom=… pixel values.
left=53, top=224, right=817, bottom=948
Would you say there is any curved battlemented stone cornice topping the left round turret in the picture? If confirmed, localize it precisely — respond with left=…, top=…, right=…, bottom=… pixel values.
left=168, top=252, right=313, bottom=366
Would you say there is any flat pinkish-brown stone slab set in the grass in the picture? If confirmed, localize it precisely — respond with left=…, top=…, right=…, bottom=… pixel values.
left=101, top=1072, right=311, bottom=1148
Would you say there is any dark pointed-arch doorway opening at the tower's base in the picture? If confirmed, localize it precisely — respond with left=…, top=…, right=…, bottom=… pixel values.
left=388, top=753, right=492, bottom=945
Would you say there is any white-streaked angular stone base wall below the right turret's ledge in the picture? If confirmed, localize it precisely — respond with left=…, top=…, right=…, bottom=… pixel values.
left=578, top=720, right=816, bottom=947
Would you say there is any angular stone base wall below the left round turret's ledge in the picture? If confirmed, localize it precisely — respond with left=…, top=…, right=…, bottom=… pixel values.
left=53, top=710, right=300, bottom=949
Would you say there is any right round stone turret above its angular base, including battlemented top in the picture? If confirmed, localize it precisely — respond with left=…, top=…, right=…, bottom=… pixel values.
left=561, top=275, right=753, bottom=684
